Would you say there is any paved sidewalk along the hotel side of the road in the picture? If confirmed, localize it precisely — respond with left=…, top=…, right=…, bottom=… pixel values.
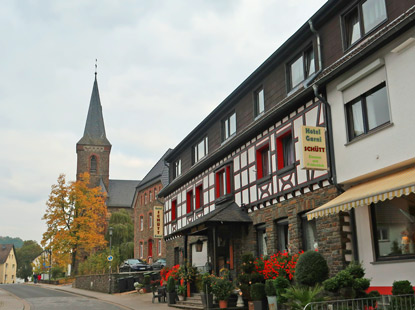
left=30, top=284, right=172, bottom=310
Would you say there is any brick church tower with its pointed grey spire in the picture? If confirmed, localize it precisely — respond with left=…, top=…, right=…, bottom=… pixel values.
left=76, top=72, right=111, bottom=191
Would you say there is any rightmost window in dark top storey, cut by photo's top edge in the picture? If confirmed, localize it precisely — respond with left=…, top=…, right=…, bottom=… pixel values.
left=343, top=0, right=387, bottom=48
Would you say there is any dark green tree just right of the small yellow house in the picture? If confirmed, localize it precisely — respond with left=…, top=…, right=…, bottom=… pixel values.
left=16, top=240, right=43, bottom=282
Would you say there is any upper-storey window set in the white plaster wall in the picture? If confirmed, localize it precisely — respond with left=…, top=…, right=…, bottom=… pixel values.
left=346, top=82, right=390, bottom=141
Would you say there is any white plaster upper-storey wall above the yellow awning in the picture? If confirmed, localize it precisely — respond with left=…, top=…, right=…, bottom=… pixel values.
left=327, top=30, right=415, bottom=183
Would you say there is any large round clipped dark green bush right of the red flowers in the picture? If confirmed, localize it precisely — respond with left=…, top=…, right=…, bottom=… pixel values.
left=295, top=251, right=329, bottom=286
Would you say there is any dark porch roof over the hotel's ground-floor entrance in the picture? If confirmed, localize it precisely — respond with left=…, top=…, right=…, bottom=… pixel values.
left=170, top=201, right=252, bottom=236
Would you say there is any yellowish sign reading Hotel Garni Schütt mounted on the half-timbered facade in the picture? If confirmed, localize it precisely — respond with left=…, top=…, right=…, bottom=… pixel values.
left=300, top=126, right=327, bottom=170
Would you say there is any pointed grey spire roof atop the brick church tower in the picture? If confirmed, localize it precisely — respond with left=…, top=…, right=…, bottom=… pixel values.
left=78, top=74, right=111, bottom=146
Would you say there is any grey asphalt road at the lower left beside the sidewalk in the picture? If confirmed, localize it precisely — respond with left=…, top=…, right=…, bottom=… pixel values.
left=1, top=284, right=125, bottom=310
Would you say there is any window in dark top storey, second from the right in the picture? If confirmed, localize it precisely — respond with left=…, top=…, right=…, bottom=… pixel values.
left=288, top=47, right=316, bottom=90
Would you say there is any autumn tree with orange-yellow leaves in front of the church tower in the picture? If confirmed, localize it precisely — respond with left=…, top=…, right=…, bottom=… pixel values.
left=41, top=173, right=107, bottom=273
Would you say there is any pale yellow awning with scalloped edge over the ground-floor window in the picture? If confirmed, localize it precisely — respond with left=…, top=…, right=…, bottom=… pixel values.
left=307, top=168, right=415, bottom=220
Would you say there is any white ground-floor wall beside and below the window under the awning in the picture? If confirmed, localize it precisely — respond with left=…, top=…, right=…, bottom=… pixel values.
left=356, top=206, right=415, bottom=286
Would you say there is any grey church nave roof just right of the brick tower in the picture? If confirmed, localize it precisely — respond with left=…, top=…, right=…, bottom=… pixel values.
left=107, top=180, right=140, bottom=208
